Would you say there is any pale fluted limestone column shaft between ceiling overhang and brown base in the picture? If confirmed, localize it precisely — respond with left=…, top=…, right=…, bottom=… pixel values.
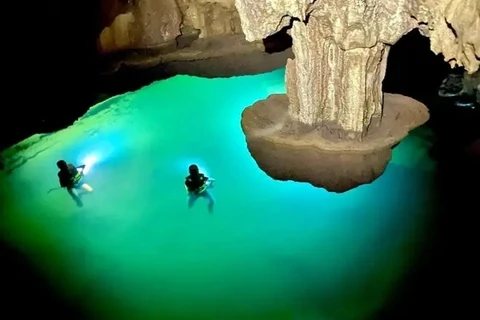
left=286, top=17, right=389, bottom=138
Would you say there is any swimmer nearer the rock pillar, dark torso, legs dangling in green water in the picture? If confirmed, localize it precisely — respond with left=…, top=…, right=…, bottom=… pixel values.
left=185, top=164, right=215, bottom=213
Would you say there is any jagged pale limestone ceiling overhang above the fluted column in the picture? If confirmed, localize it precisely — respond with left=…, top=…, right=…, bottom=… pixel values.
left=235, top=0, right=480, bottom=73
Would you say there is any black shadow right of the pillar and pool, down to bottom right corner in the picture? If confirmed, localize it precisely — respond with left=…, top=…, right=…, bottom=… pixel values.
left=377, top=31, right=480, bottom=320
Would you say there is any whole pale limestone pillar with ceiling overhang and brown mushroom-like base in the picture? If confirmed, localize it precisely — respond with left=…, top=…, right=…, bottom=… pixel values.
left=235, top=0, right=480, bottom=192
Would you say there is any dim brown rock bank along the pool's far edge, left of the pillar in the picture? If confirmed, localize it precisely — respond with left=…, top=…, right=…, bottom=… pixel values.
left=98, top=35, right=293, bottom=95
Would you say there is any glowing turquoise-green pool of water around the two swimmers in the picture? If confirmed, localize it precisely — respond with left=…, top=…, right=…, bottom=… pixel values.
left=0, top=70, right=434, bottom=320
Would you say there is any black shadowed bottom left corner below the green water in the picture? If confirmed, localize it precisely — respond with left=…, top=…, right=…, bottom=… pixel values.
left=0, top=239, right=88, bottom=320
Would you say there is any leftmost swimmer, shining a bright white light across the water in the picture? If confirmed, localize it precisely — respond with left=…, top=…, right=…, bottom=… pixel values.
left=57, top=160, right=93, bottom=207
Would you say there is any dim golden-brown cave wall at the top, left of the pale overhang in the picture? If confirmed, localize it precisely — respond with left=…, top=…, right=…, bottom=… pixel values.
left=97, top=0, right=242, bottom=54
